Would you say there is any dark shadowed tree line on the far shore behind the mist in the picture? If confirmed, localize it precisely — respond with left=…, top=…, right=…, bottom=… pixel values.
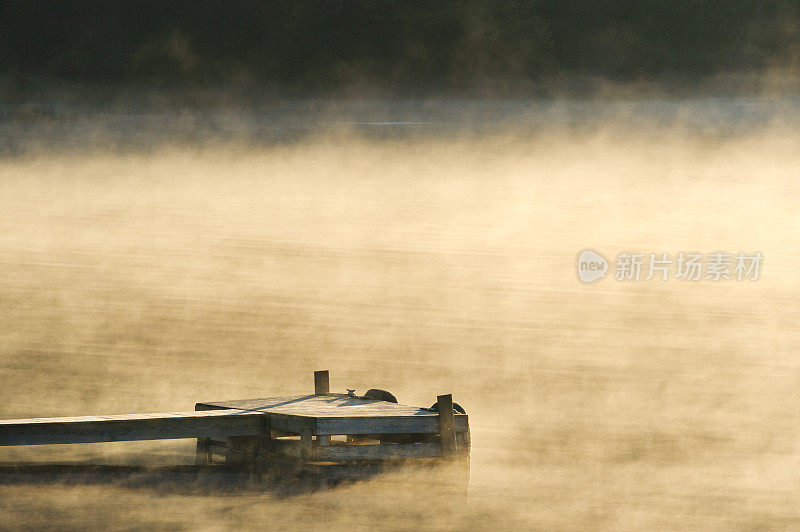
left=0, top=0, right=800, bottom=88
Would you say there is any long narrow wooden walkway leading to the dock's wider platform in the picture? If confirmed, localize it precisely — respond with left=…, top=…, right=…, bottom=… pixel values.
left=0, top=410, right=263, bottom=446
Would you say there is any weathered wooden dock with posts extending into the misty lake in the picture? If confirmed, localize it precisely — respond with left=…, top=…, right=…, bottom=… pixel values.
left=0, top=371, right=470, bottom=472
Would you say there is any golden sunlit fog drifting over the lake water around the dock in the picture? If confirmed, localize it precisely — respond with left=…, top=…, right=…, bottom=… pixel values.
left=0, top=96, right=800, bottom=530
